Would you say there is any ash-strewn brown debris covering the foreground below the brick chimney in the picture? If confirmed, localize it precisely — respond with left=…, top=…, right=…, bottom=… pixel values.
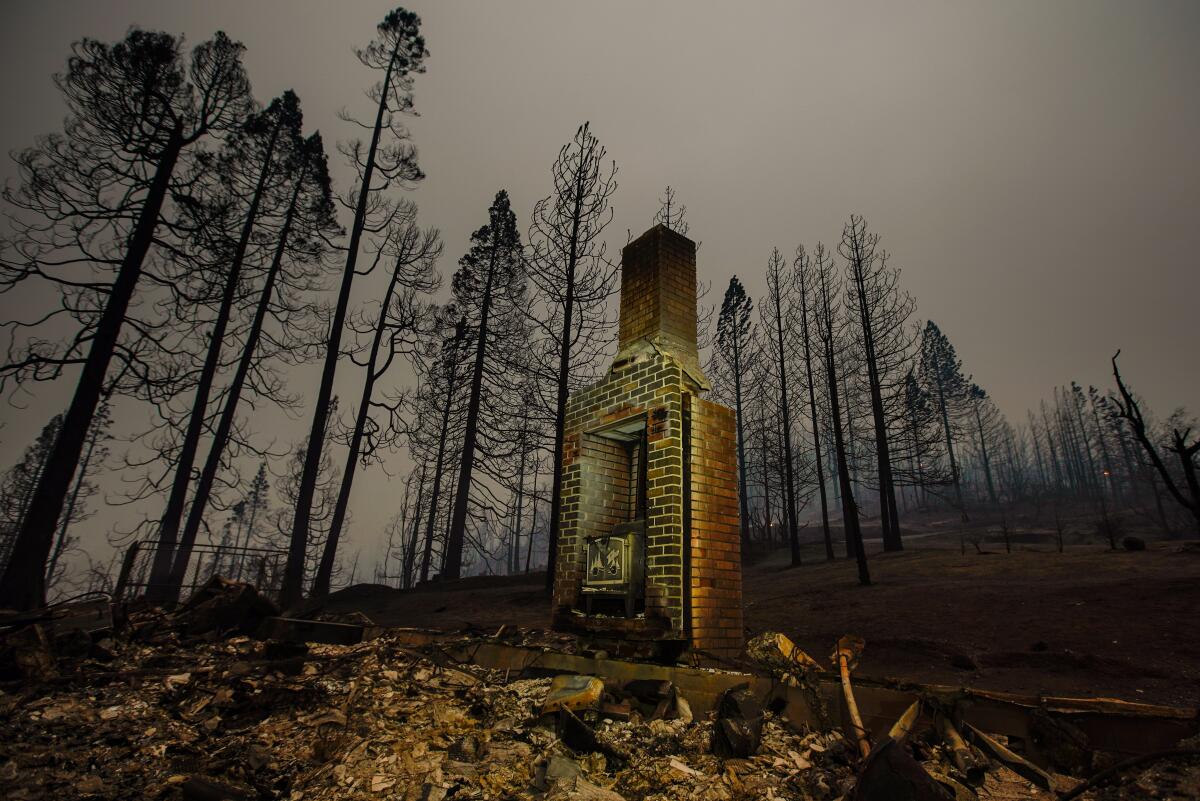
left=0, top=585, right=1200, bottom=801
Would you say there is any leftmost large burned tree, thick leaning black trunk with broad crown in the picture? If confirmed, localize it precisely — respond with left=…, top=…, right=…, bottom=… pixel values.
left=0, top=29, right=250, bottom=609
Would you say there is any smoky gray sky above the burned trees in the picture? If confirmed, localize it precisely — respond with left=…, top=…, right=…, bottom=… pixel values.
left=0, top=0, right=1200, bottom=575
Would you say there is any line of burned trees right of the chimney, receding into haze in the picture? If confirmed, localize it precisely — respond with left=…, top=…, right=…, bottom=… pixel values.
left=707, top=215, right=1200, bottom=584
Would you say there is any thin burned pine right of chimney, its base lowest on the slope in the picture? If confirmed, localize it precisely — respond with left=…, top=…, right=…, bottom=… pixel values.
left=812, top=242, right=871, bottom=586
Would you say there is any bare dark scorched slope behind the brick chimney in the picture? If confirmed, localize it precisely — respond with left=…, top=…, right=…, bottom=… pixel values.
left=331, top=520, right=1200, bottom=706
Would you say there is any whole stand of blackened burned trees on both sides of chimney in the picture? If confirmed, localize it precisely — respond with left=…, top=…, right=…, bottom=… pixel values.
left=0, top=8, right=1200, bottom=609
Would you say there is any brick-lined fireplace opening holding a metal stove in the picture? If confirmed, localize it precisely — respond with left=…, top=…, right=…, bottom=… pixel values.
left=580, top=415, right=649, bottom=618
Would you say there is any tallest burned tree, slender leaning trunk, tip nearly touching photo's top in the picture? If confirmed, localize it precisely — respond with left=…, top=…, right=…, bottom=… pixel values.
left=280, top=8, right=428, bottom=607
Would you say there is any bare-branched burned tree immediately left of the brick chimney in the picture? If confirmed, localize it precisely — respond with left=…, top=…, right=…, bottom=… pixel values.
left=528, top=122, right=617, bottom=589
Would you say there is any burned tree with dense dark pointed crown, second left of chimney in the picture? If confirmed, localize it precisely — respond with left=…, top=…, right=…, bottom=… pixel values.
left=442, top=189, right=524, bottom=578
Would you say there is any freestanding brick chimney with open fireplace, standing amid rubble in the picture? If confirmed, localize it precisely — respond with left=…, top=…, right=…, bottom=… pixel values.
left=553, top=225, right=743, bottom=656
